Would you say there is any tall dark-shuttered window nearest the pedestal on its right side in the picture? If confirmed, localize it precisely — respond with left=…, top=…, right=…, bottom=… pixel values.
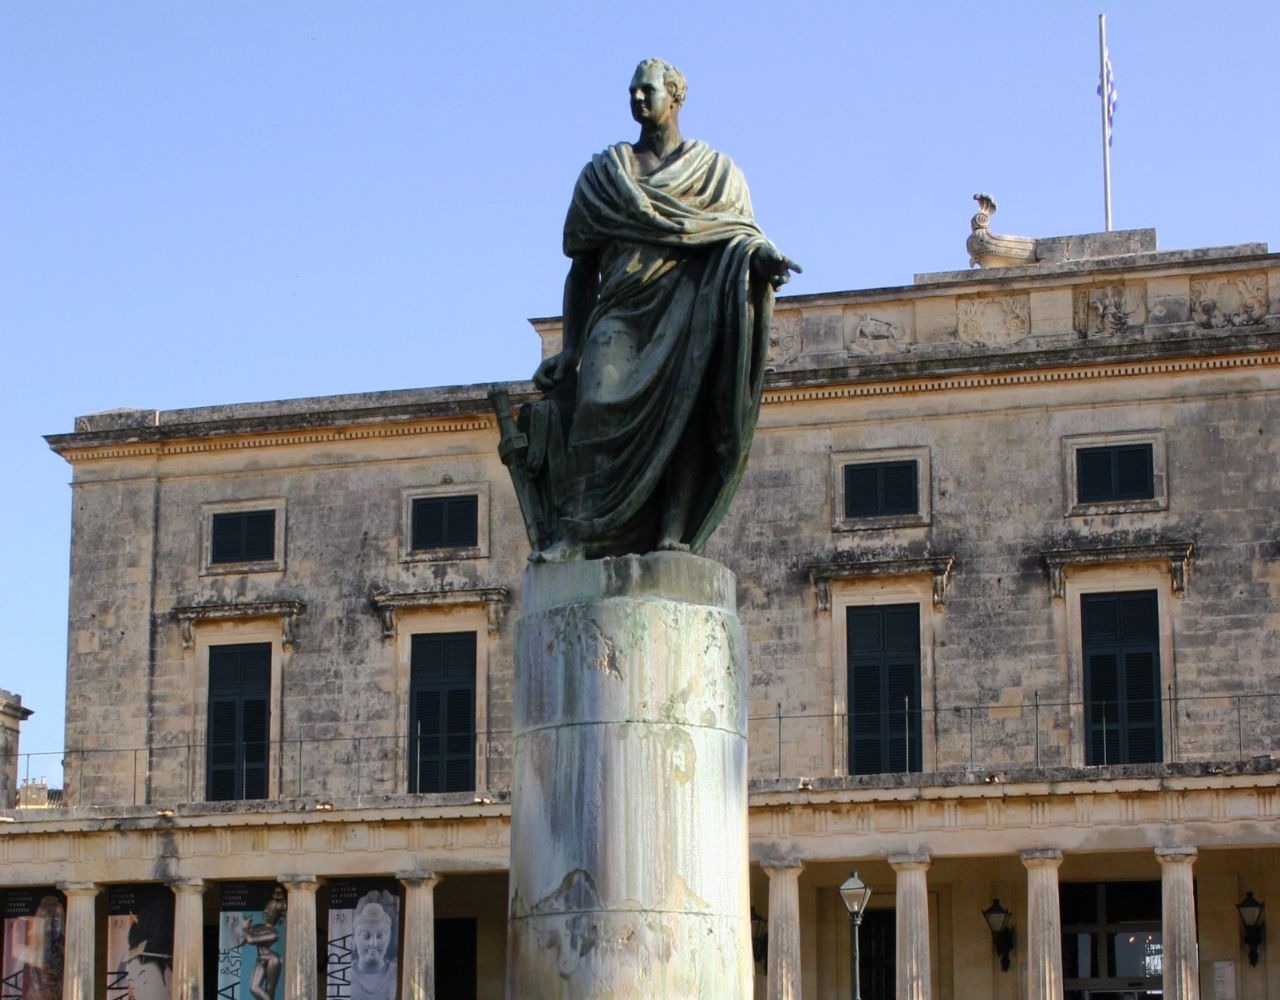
left=845, top=604, right=922, bottom=775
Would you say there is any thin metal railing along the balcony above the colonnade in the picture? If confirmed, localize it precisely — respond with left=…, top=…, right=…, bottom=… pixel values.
left=18, top=691, right=1280, bottom=807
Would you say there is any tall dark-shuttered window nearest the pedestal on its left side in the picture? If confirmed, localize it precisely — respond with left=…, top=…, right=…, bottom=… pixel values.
left=408, top=633, right=476, bottom=791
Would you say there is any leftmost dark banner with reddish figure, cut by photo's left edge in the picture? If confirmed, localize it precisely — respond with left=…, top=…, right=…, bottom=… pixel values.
left=0, top=886, right=67, bottom=1000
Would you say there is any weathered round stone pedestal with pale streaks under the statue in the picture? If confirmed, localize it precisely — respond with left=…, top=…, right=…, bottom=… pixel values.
left=507, top=553, right=753, bottom=1000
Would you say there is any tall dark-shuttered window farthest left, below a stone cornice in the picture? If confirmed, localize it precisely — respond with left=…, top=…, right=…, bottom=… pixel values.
left=205, top=643, right=271, bottom=802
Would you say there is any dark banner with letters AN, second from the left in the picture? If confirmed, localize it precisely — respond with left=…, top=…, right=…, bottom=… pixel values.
left=106, top=885, right=173, bottom=1000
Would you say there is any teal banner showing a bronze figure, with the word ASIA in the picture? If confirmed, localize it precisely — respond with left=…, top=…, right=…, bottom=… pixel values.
left=216, top=882, right=288, bottom=1000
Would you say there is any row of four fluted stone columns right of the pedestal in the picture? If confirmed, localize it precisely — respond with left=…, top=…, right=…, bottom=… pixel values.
left=763, top=848, right=1199, bottom=1000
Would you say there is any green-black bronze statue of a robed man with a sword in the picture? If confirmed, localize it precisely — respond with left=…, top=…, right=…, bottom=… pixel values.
left=492, top=59, right=800, bottom=560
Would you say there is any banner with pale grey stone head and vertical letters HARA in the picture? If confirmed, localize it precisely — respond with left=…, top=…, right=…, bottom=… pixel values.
left=325, top=878, right=399, bottom=1000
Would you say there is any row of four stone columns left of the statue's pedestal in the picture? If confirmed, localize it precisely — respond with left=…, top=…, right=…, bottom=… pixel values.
left=58, top=872, right=440, bottom=1000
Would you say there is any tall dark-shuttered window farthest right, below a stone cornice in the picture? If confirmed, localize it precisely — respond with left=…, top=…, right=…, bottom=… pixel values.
left=1080, top=590, right=1164, bottom=764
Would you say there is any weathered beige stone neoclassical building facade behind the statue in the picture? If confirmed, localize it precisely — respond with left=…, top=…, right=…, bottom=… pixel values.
left=0, top=230, right=1280, bottom=1000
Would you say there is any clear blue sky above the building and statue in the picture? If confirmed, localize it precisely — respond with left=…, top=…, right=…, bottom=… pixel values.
left=0, top=0, right=1280, bottom=777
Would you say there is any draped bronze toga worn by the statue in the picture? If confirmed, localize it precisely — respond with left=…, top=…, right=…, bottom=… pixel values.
left=561, top=141, right=773, bottom=556
